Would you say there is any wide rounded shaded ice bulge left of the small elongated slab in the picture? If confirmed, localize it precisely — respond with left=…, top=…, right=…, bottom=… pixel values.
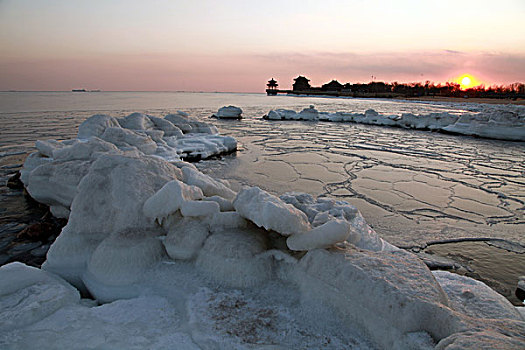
left=197, top=229, right=271, bottom=287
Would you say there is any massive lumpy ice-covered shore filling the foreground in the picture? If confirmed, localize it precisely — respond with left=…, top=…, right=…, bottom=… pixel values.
left=0, top=113, right=525, bottom=349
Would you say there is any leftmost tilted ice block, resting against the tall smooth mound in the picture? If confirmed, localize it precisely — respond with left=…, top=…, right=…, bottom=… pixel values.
left=144, top=180, right=203, bottom=220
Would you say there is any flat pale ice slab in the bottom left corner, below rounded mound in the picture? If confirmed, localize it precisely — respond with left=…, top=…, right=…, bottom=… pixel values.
left=0, top=296, right=202, bottom=350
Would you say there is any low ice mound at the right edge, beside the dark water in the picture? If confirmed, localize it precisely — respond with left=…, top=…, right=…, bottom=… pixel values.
left=433, top=271, right=524, bottom=321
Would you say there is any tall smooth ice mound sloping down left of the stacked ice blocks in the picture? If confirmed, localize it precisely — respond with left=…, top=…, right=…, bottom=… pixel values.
left=43, top=155, right=182, bottom=287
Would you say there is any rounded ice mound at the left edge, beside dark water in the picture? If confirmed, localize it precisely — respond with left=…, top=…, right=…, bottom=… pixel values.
left=0, top=262, right=80, bottom=332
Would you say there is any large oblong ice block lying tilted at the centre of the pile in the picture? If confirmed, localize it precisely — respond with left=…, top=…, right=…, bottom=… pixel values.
left=233, top=187, right=310, bottom=236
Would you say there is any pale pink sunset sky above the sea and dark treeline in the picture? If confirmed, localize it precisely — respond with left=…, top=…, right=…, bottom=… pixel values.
left=0, top=0, right=525, bottom=92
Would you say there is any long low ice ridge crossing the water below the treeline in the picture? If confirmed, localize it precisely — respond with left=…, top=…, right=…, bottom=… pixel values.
left=263, top=105, right=525, bottom=141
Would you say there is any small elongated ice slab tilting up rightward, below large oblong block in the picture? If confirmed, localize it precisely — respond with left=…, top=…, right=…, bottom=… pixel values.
left=286, top=219, right=350, bottom=250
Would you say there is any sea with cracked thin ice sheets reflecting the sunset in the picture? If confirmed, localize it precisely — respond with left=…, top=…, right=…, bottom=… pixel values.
left=0, top=92, right=525, bottom=305
